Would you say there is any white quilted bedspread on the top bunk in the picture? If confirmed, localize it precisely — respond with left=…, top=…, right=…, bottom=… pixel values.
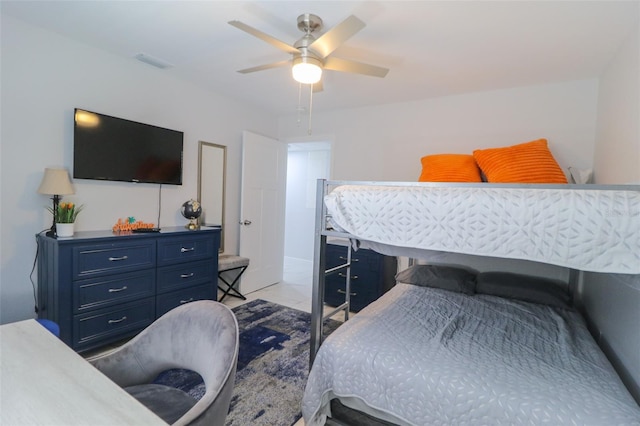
left=325, top=185, right=640, bottom=274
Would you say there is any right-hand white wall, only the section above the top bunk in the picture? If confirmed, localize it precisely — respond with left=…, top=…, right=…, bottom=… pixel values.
left=594, top=22, right=640, bottom=184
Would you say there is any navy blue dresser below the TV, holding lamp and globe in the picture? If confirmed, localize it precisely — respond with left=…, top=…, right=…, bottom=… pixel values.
left=38, top=227, right=220, bottom=352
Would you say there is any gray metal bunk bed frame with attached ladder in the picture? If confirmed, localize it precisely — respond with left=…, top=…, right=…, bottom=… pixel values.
left=309, top=179, right=640, bottom=368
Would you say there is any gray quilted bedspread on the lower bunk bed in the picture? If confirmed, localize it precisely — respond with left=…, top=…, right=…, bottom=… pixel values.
left=303, top=284, right=640, bottom=426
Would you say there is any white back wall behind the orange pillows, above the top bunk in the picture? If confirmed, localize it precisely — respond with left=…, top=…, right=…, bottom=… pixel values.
left=279, top=77, right=598, bottom=181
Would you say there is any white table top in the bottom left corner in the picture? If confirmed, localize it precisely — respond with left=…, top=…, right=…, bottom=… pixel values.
left=0, top=320, right=166, bottom=426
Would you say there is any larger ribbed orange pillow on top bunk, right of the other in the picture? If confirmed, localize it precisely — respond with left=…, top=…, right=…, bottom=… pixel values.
left=473, top=139, right=567, bottom=183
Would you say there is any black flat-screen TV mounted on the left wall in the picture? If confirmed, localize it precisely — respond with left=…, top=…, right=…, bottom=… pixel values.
left=73, top=108, right=184, bottom=185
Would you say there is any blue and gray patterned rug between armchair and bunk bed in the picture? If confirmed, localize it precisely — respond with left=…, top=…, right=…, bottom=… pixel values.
left=156, top=299, right=341, bottom=426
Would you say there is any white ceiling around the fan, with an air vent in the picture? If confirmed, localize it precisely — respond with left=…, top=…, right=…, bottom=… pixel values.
left=1, top=0, right=640, bottom=114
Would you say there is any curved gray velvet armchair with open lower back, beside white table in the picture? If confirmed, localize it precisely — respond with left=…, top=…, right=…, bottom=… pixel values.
left=91, top=300, right=238, bottom=426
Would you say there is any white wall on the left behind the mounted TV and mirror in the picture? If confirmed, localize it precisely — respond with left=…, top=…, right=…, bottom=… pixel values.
left=0, top=15, right=277, bottom=323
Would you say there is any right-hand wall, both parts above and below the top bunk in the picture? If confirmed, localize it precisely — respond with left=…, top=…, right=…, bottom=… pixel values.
left=580, top=25, right=640, bottom=403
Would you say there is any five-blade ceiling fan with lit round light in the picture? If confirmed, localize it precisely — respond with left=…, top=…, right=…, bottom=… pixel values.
left=229, top=13, right=389, bottom=84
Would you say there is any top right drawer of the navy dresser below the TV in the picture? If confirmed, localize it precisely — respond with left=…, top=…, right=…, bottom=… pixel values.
left=158, top=233, right=218, bottom=265
